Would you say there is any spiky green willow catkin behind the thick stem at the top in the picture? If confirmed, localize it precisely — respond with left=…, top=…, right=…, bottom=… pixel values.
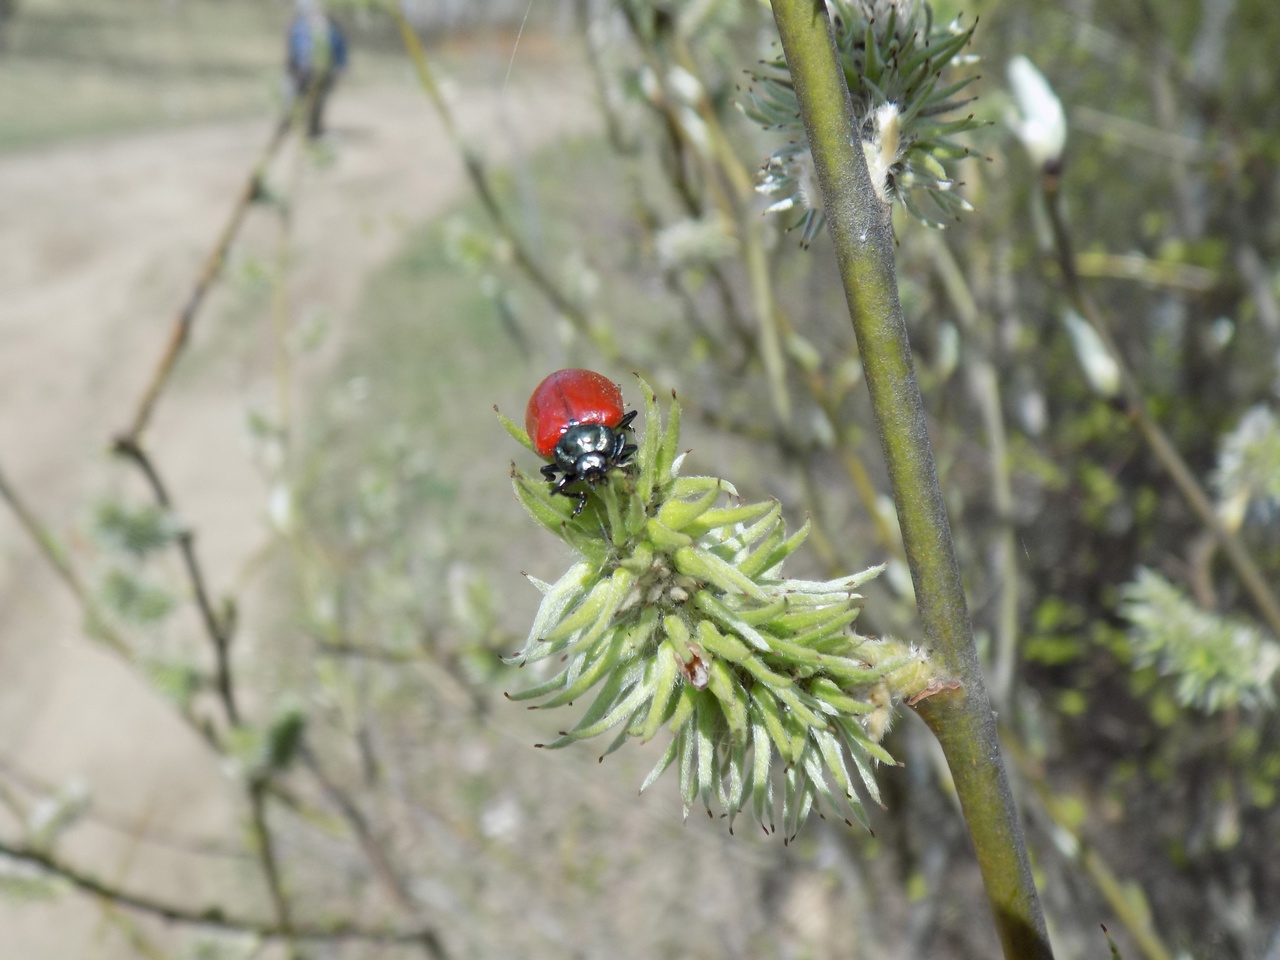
left=742, top=0, right=984, bottom=236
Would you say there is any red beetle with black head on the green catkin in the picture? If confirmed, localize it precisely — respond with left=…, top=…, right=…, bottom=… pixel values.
left=525, top=369, right=636, bottom=516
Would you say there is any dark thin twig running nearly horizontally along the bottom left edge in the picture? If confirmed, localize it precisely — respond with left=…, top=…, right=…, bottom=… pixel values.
left=0, top=840, right=443, bottom=955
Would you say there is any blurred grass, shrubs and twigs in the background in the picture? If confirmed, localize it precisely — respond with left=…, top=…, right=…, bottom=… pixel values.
left=0, top=0, right=1280, bottom=960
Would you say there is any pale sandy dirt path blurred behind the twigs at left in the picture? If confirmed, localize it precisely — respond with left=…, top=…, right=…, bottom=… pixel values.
left=0, top=69, right=593, bottom=960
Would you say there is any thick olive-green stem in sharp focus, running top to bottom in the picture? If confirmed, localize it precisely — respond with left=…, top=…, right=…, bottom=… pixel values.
left=773, top=0, right=1052, bottom=960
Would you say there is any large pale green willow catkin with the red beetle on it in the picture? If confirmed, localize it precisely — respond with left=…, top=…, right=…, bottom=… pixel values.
left=502, top=381, right=929, bottom=840
